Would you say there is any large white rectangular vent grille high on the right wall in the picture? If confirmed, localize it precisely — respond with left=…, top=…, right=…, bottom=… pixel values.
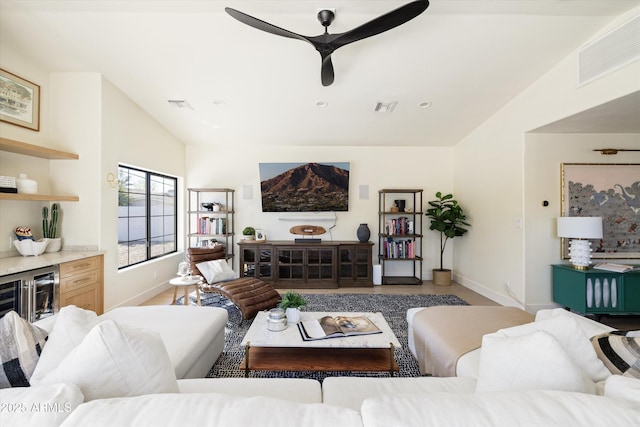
left=578, top=16, right=640, bottom=86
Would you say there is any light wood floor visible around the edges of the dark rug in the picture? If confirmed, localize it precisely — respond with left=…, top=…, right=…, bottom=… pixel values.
left=141, top=280, right=640, bottom=330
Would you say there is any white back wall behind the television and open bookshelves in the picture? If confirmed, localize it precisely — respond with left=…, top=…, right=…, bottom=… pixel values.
left=186, top=141, right=453, bottom=279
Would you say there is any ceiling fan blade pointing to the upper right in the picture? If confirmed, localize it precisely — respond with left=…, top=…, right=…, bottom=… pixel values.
left=331, top=0, right=429, bottom=50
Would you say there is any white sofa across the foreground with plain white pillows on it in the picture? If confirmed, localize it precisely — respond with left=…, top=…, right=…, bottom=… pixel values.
left=0, top=307, right=640, bottom=427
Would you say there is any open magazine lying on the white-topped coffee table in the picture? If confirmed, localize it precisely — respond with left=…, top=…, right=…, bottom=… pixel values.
left=298, top=316, right=382, bottom=341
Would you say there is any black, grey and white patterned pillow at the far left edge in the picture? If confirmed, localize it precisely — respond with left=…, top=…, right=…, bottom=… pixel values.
left=0, top=311, right=47, bottom=389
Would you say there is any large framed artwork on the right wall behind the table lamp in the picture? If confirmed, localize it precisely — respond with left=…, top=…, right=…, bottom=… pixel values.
left=561, top=163, right=640, bottom=259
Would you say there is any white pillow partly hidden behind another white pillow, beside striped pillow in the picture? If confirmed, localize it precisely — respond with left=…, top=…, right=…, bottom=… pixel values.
left=490, top=316, right=611, bottom=382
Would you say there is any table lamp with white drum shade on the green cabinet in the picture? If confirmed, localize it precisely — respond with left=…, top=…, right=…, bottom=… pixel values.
left=558, top=216, right=602, bottom=270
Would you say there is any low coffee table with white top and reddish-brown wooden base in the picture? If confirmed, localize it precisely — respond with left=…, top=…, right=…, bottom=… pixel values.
left=241, top=311, right=400, bottom=376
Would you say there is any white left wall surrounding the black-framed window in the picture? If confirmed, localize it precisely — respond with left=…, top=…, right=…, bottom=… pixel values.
left=96, top=79, right=185, bottom=308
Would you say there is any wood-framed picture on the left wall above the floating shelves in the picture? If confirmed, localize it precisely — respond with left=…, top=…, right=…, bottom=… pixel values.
left=0, top=68, right=40, bottom=131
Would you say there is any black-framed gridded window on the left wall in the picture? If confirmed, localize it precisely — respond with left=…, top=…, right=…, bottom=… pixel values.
left=118, top=166, right=177, bottom=269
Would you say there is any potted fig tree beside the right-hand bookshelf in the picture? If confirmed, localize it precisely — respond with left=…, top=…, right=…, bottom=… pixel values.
left=425, top=191, right=471, bottom=286
